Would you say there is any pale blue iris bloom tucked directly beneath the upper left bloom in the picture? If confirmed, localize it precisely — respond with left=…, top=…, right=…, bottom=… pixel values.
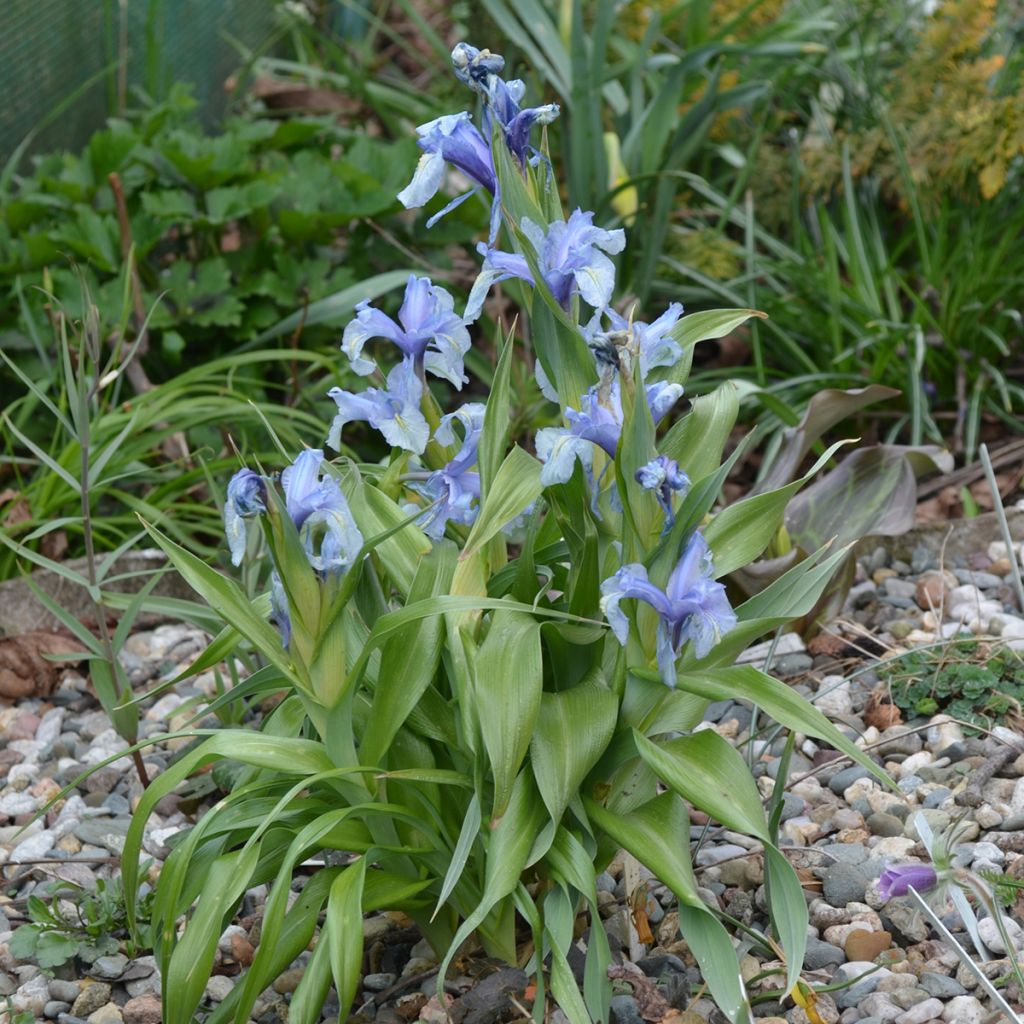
left=327, top=358, right=430, bottom=455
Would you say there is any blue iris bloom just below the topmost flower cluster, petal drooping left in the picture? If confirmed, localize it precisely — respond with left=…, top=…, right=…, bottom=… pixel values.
left=466, top=209, right=626, bottom=319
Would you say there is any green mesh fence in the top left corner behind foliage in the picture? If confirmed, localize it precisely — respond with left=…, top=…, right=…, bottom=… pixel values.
left=0, top=0, right=274, bottom=161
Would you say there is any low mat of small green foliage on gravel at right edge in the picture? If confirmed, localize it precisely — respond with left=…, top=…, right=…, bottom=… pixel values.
left=887, top=641, right=1024, bottom=728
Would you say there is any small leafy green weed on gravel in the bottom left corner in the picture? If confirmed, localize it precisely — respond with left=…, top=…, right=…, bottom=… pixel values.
left=10, top=879, right=153, bottom=970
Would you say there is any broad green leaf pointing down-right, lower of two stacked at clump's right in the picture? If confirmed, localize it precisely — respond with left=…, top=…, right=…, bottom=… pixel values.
left=584, top=791, right=703, bottom=907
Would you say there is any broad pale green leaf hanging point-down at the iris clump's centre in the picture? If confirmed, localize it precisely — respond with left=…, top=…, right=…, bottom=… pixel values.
left=473, top=611, right=544, bottom=819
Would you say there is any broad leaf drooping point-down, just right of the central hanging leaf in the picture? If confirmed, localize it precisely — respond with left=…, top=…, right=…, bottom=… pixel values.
left=530, top=684, right=618, bottom=821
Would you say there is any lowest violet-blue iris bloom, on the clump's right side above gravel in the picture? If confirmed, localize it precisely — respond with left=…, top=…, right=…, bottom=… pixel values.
left=601, top=532, right=736, bottom=688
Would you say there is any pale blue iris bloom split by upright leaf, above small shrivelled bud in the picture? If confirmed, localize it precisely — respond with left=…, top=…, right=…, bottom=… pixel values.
left=537, top=377, right=683, bottom=487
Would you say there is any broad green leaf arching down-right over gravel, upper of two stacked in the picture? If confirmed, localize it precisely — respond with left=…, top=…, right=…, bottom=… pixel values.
left=633, top=729, right=768, bottom=842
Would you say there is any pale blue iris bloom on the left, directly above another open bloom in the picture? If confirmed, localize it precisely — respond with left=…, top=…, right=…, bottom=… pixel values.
left=341, top=274, right=470, bottom=390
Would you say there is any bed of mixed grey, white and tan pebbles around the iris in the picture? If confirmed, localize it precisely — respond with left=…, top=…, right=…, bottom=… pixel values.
left=0, top=544, right=1024, bottom=1024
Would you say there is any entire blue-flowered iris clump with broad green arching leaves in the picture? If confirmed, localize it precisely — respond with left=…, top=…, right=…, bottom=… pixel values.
left=130, top=44, right=878, bottom=1024
